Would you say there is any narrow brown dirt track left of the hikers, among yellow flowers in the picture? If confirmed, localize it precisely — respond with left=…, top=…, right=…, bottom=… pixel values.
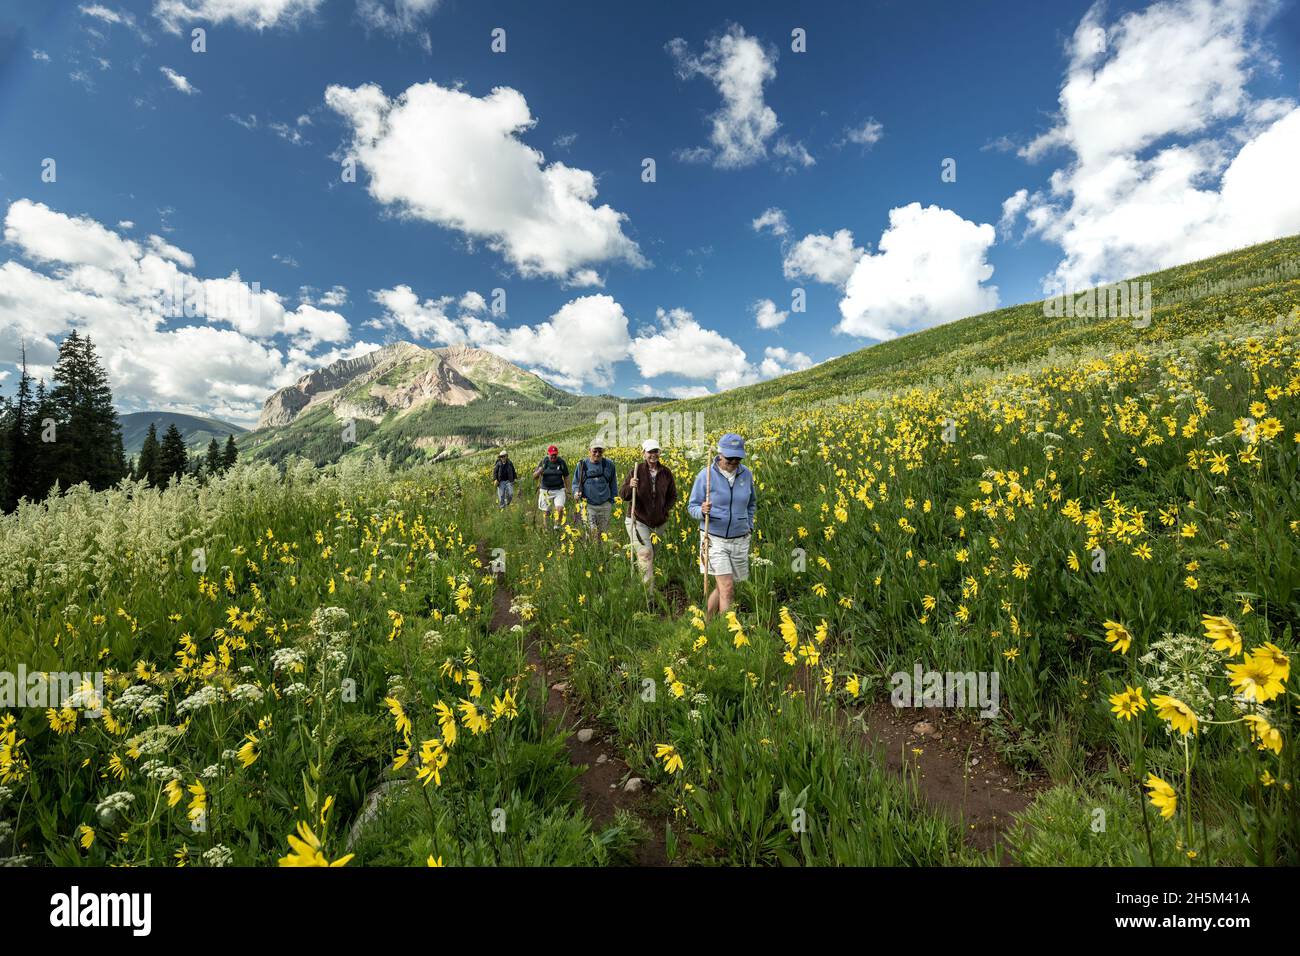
left=478, top=541, right=668, bottom=866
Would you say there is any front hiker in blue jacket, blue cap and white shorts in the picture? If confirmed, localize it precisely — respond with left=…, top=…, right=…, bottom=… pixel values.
left=686, top=432, right=758, bottom=617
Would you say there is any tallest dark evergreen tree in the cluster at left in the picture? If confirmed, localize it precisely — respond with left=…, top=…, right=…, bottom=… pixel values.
left=49, top=329, right=126, bottom=490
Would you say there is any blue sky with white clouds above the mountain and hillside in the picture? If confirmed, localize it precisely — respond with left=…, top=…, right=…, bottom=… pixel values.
left=0, top=0, right=1300, bottom=423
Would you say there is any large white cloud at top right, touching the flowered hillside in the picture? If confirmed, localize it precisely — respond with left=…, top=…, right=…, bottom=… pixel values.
left=1004, top=0, right=1300, bottom=291
